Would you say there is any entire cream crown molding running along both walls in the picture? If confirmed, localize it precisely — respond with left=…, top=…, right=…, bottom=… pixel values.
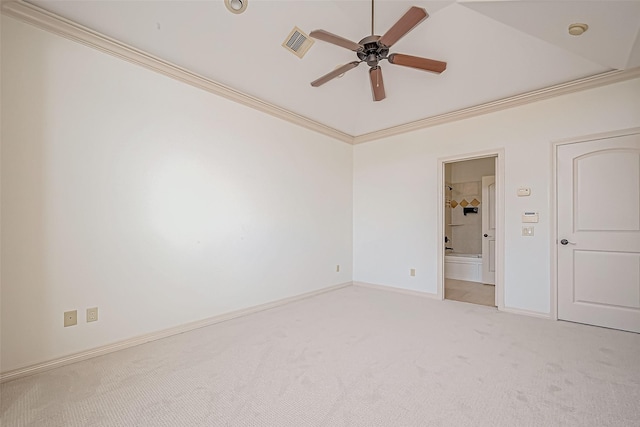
left=0, top=0, right=640, bottom=144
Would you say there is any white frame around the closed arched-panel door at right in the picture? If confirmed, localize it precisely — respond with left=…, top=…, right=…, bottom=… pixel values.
left=549, top=127, right=640, bottom=320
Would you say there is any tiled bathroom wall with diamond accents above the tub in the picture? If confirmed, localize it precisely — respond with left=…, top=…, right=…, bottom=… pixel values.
left=445, top=157, right=495, bottom=254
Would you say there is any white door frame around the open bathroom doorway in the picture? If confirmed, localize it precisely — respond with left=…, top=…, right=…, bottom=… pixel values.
left=436, top=148, right=505, bottom=310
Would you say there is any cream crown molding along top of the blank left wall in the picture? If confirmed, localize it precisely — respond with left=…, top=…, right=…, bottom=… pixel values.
left=2, top=0, right=353, bottom=144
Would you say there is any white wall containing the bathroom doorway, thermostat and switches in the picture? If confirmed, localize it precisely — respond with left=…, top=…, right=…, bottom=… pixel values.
left=354, top=75, right=640, bottom=313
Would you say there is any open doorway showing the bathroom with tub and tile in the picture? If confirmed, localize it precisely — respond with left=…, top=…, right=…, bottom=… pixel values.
left=439, top=153, right=501, bottom=307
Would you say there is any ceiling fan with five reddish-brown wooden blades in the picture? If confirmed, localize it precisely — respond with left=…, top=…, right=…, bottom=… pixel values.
left=309, top=0, right=447, bottom=101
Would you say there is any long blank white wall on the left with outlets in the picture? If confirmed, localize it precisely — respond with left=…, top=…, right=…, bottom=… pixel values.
left=1, top=17, right=353, bottom=372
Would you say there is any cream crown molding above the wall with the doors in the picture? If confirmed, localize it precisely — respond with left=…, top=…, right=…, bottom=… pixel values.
left=353, top=67, right=640, bottom=144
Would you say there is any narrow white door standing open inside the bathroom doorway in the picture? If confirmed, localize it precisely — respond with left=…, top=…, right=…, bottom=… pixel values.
left=481, top=176, right=497, bottom=286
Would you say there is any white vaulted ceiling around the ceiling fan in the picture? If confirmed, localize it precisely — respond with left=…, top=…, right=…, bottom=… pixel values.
left=22, top=0, right=640, bottom=136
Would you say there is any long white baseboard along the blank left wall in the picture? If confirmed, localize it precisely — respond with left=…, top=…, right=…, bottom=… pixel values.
left=0, top=282, right=353, bottom=384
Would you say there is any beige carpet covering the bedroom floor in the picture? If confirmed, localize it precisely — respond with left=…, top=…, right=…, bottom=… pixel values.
left=0, top=286, right=640, bottom=427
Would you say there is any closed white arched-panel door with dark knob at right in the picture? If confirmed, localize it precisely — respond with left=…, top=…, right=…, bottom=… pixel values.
left=556, top=134, right=640, bottom=332
